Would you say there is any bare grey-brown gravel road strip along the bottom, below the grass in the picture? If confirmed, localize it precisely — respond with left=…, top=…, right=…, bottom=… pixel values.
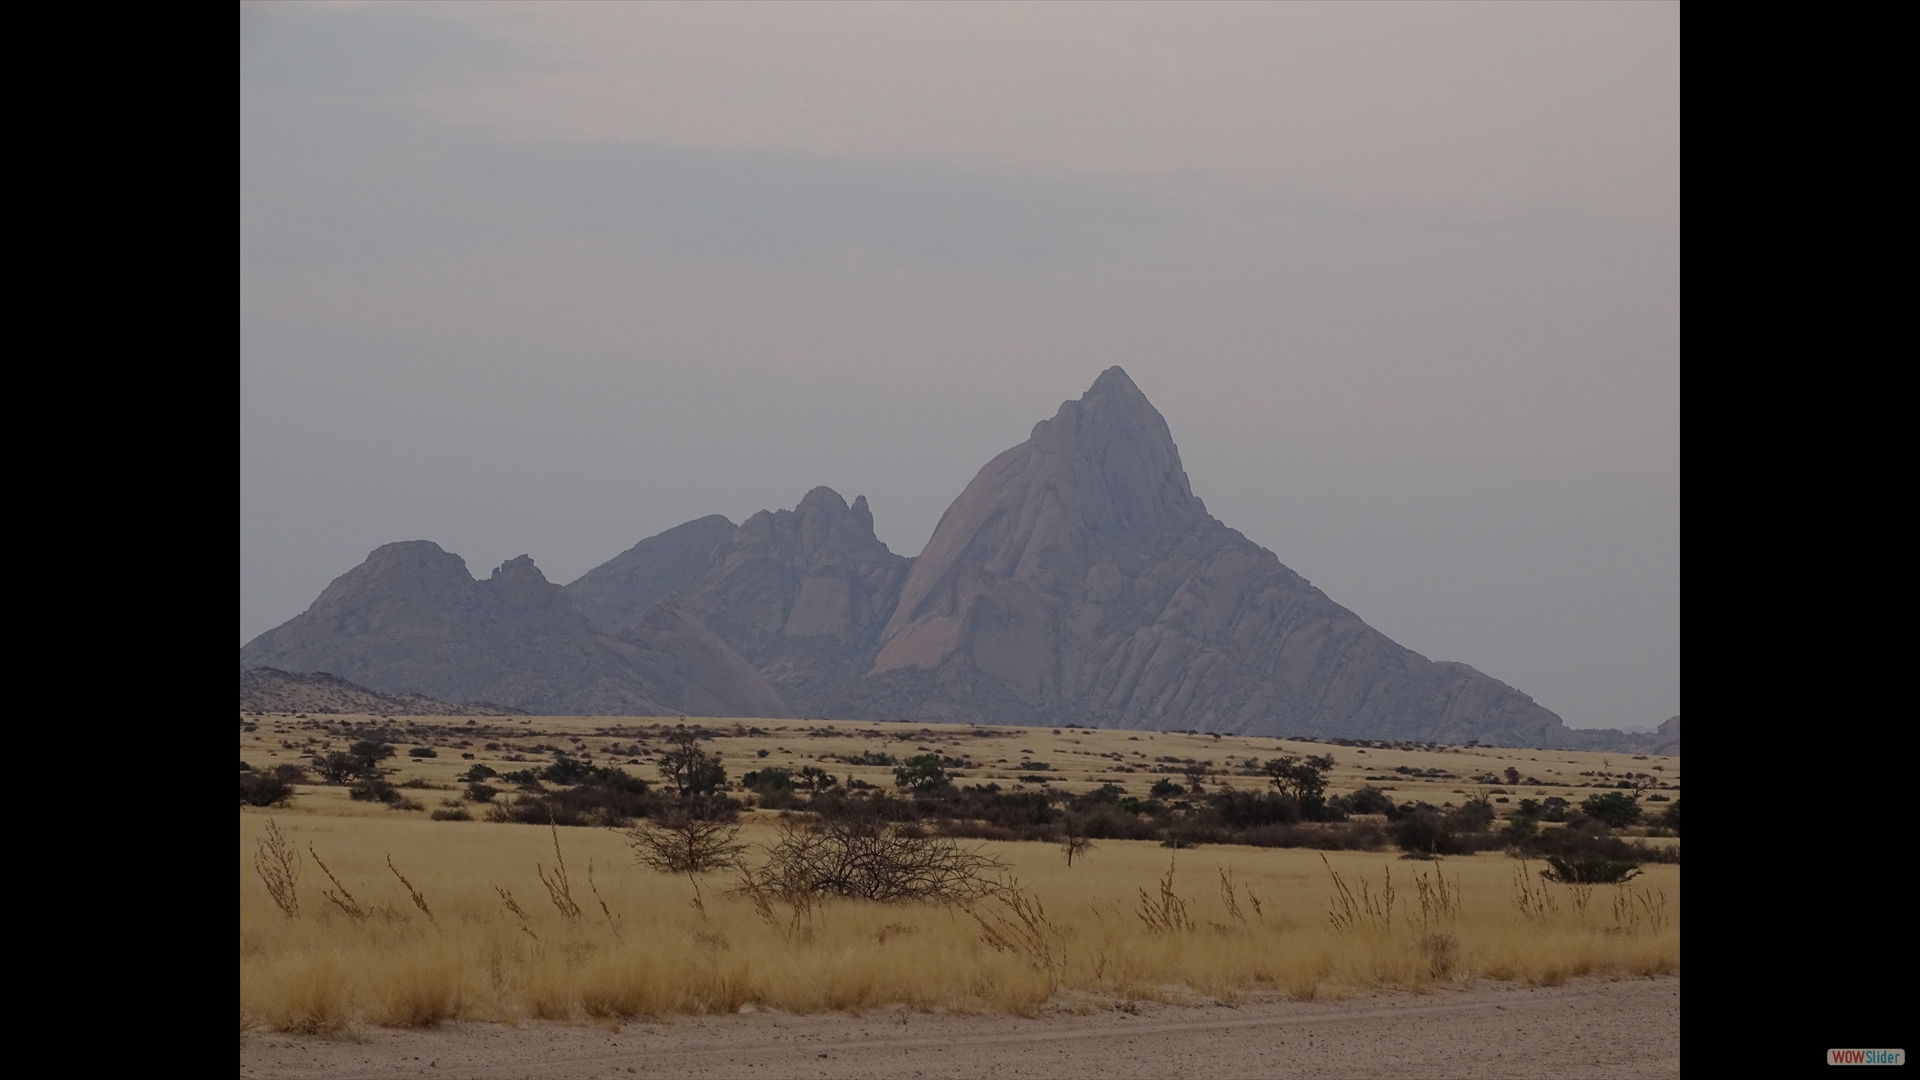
left=240, top=976, right=1680, bottom=1080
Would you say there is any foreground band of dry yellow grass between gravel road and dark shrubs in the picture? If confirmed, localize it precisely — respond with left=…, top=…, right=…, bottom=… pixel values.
left=240, top=807, right=1680, bottom=1030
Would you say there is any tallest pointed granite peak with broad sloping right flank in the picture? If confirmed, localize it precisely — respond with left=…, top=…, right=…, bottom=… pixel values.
left=864, top=367, right=1567, bottom=746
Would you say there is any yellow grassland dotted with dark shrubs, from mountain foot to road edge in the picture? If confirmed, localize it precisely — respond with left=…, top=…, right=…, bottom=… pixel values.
left=240, top=717, right=1680, bottom=1032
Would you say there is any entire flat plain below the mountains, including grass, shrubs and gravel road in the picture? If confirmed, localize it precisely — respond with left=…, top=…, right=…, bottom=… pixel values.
left=240, top=715, right=1680, bottom=1076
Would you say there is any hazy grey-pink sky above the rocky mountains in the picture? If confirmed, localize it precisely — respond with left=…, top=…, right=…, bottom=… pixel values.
left=240, top=2, right=1680, bottom=726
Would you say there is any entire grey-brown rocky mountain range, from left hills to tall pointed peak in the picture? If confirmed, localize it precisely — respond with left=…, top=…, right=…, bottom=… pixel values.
left=242, top=367, right=1678, bottom=749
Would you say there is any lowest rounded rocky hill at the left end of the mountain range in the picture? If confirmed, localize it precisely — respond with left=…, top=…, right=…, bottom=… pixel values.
left=240, top=540, right=789, bottom=717
